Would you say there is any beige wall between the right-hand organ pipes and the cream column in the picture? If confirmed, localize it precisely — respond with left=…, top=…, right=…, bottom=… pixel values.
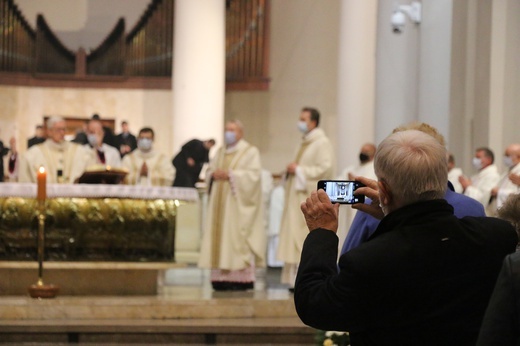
left=225, top=0, right=340, bottom=173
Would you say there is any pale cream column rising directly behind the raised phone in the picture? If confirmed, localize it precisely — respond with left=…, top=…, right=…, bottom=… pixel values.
left=337, top=0, right=377, bottom=173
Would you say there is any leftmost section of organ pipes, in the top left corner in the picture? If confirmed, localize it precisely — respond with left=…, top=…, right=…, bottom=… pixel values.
left=0, top=0, right=36, bottom=72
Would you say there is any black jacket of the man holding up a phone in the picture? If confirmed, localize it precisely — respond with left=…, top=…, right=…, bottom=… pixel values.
left=294, top=200, right=518, bottom=346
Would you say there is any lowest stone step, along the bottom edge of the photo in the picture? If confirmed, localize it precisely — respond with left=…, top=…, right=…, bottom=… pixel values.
left=0, top=317, right=316, bottom=346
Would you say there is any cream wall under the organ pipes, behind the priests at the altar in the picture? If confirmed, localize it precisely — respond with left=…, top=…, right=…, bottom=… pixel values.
left=0, top=86, right=172, bottom=155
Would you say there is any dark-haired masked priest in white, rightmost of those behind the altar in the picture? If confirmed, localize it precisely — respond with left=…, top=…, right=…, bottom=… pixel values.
left=122, top=127, right=175, bottom=186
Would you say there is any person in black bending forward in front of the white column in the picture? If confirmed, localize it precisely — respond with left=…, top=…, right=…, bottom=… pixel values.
left=172, top=139, right=215, bottom=187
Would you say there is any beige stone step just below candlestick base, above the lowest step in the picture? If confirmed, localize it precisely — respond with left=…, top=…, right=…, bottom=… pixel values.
left=0, top=296, right=296, bottom=322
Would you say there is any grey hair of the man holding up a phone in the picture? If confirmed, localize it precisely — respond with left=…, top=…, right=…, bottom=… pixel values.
left=374, top=130, right=448, bottom=205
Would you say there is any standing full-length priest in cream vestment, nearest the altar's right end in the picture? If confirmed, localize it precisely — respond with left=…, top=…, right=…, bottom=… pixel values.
left=199, top=120, right=267, bottom=290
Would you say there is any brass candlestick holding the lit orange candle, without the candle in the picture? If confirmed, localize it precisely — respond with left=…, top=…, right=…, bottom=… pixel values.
left=29, top=199, right=59, bottom=298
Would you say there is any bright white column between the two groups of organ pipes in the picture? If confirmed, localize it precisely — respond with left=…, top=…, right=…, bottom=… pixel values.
left=173, top=0, right=225, bottom=153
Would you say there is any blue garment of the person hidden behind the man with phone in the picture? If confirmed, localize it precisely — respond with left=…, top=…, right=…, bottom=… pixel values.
left=341, top=181, right=486, bottom=255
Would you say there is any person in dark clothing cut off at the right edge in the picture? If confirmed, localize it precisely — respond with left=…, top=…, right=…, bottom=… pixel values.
left=477, top=194, right=520, bottom=346
